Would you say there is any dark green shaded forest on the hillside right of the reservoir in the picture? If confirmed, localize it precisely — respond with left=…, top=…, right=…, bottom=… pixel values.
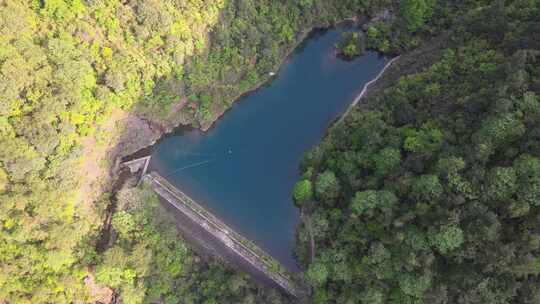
left=295, top=0, right=540, bottom=304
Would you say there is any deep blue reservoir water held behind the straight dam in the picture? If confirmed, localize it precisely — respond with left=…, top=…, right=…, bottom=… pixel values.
left=151, top=29, right=387, bottom=270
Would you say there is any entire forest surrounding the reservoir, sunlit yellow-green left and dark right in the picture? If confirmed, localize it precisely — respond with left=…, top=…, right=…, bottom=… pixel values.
left=0, top=0, right=540, bottom=303
